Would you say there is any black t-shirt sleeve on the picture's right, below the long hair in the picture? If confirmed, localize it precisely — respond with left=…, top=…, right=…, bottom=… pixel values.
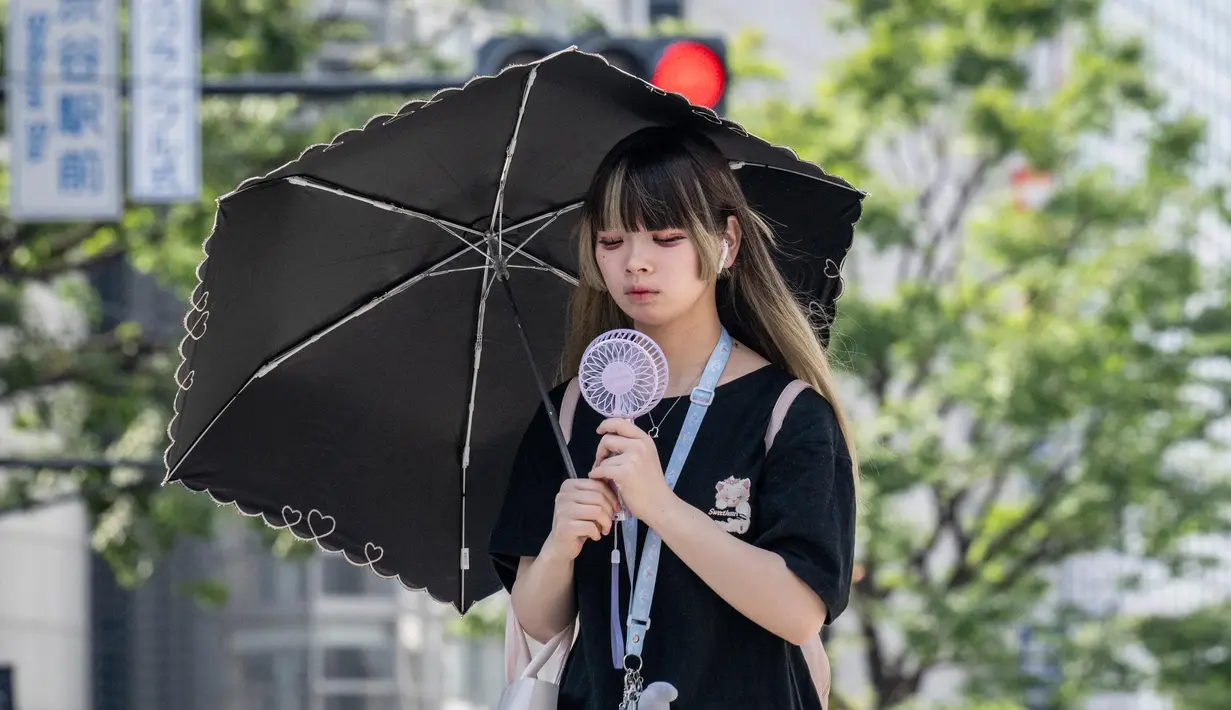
left=753, top=390, right=856, bottom=624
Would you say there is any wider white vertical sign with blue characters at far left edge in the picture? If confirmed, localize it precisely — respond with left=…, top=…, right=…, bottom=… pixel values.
left=5, top=0, right=123, bottom=221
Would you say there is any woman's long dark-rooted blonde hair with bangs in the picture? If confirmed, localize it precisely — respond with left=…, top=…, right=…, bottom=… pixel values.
left=560, top=127, right=859, bottom=481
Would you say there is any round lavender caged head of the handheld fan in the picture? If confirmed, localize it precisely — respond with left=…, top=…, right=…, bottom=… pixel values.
left=577, top=329, right=667, bottom=420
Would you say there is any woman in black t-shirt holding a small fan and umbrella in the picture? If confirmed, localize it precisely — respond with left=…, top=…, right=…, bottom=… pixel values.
left=490, top=128, right=858, bottom=710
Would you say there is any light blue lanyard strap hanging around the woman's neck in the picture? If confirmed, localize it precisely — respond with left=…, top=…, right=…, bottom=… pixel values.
left=620, top=327, right=731, bottom=667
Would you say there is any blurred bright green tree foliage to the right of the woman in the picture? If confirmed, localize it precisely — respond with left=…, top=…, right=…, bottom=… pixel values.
left=735, top=0, right=1231, bottom=710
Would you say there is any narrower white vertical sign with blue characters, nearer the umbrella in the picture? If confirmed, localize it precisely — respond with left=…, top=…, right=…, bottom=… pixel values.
left=128, top=0, right=201, bottom=203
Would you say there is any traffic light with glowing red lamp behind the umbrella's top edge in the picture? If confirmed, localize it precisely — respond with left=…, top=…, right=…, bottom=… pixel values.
left=475, top=34, right=729, bottom=113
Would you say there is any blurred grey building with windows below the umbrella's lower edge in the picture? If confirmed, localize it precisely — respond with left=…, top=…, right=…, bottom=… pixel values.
left=91, top=514, right=503, bottom=710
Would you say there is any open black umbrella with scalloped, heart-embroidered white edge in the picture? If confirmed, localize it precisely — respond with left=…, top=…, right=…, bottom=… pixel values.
left=166, top=50, right=863, bottom=613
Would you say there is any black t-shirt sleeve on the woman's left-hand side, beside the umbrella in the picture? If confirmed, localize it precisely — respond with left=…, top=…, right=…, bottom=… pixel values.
left=487, top=386, right=567, bottom=591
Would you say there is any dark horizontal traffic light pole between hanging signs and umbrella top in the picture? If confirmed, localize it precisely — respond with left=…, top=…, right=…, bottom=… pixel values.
left=0, top=74, right=467, bottom=102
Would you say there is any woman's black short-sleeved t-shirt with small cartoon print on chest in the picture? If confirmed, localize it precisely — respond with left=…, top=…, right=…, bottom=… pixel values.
left=490, top=367, right=854, bottom=710
